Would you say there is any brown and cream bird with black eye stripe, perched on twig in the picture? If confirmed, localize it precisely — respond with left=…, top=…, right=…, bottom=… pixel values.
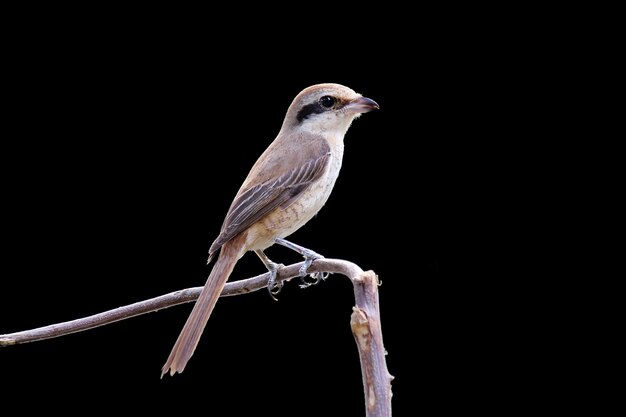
left=161, top=84, right=378, bottom=377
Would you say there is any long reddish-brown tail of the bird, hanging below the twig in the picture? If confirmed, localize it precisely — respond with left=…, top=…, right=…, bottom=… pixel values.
left=161, top=238, right=242, bottom=378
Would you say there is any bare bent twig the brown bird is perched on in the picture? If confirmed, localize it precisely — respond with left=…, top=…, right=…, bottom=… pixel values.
left=0, top=258, right=393, bottom=417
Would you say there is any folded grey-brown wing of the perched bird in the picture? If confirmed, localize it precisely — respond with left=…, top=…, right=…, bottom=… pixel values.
left=209, top=152, right=330, bottom=254
